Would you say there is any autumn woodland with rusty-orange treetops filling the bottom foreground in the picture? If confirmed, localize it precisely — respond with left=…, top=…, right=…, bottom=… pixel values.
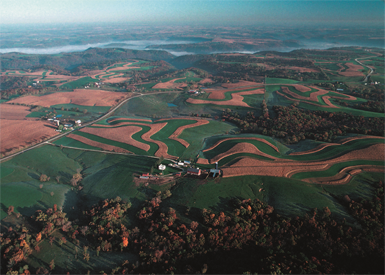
left=0, top=181, right=385, bottom=275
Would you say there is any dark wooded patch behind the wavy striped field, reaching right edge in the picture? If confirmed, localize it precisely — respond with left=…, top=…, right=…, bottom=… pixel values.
left=222, top=105, right=385, bottom=143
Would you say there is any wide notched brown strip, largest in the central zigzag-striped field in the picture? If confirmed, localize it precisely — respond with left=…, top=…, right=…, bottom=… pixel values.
left=80, top=126, right=150, bottom=152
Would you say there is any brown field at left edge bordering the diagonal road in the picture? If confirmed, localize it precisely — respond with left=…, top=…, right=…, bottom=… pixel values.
left=0, top=119, right=58, bottom=153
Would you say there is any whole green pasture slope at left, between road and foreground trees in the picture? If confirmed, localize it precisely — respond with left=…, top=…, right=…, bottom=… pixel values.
left=0, top=147, right=172, bottom=222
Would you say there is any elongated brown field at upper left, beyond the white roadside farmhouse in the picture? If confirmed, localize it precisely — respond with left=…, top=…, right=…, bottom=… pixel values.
left=9, top=89, right=126, bottom=107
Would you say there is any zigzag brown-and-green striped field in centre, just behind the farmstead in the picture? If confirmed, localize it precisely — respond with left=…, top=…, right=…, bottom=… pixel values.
left=55, top=117, right=231, bottom=159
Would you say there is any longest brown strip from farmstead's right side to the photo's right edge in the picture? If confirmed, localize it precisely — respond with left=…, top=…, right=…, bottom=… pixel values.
left=222, top=143, right=385, bottom=181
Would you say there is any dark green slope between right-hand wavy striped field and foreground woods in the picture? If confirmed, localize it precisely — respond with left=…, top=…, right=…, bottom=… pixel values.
left=166, top=173, right=384, bottom=222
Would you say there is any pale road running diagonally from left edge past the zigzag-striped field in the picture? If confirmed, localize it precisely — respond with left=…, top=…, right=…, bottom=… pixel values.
left=0, top=91, right=182, bottom=162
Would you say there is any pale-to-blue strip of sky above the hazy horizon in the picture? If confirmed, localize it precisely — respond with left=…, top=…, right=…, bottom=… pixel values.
left=0, top=0, right=385, bottom=24
